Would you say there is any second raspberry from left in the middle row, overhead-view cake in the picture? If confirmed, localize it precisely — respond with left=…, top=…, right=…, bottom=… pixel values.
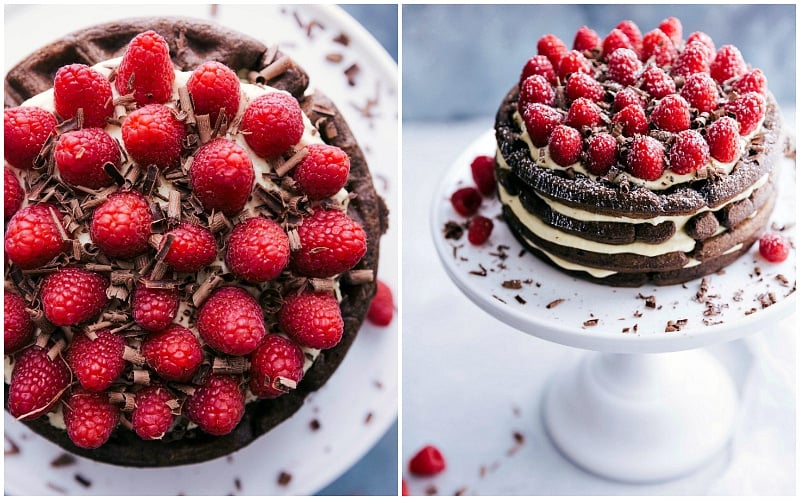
left=89, top=191, right=153, bottom=259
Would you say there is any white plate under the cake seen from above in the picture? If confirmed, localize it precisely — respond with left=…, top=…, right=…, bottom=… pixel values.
left=4, top=5, right=398, bottom=495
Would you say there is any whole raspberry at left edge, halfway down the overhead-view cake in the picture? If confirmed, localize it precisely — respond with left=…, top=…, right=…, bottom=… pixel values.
left=5, top=203, right=69, bottom=269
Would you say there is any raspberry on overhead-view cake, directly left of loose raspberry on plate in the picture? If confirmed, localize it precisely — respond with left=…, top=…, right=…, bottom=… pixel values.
left=278, top=292, right=344, bottom=349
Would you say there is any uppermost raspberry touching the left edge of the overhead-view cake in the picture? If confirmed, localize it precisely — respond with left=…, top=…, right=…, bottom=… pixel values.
left=3, top=106, right=56, bottom=170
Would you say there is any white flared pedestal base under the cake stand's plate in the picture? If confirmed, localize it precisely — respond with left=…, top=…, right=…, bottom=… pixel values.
left=543, top=349, right=738, bottom=483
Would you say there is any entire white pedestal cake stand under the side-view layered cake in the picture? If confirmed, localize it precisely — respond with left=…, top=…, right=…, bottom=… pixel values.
left=432, top=131, right=796, bottom=482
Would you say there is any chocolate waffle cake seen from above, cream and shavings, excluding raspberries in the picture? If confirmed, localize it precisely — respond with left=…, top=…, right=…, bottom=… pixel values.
left=5, top=18, right=388, bottom=467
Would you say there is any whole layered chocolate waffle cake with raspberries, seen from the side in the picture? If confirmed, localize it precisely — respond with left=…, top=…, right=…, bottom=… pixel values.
left=495, top=18, right=782, bottom=286
